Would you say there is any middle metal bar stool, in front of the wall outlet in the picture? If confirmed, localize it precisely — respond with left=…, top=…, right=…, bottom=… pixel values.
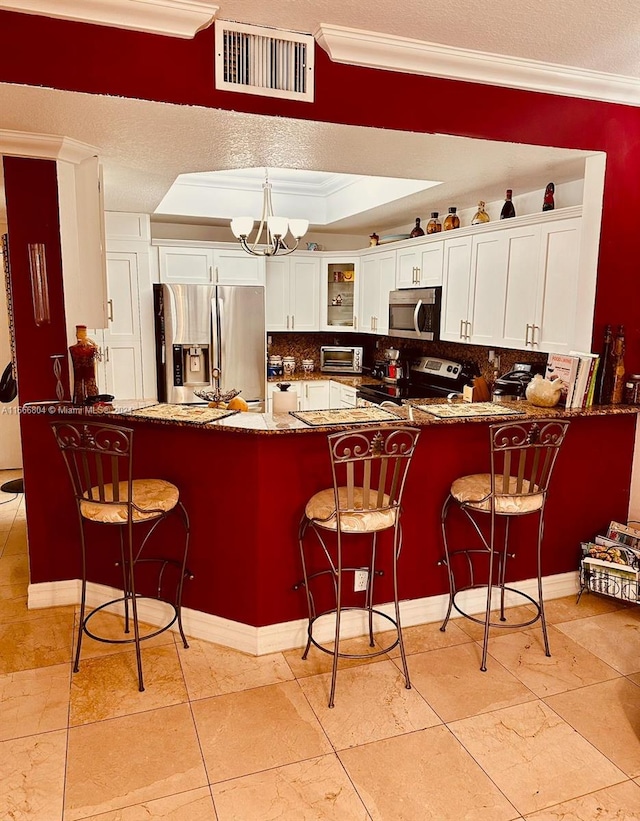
left=295, top=426, right=420, bottom=707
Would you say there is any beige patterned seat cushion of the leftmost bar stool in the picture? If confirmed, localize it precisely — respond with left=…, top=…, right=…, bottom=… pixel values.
left=80, top=479, right=179, bottom=524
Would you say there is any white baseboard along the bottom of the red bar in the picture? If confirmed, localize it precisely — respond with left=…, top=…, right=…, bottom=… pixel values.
left=28, top=571, right=579, bottom=656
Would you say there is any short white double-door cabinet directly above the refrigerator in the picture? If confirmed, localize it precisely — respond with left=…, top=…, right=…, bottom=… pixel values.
left=158, top=241, right=265, bottom=285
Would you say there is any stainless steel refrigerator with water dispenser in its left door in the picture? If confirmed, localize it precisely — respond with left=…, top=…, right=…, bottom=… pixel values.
left=153, top=283, right=266, bottom=403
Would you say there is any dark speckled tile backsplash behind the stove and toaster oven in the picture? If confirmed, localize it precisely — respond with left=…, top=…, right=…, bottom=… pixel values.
left=268, top=333, right=547, bottom=383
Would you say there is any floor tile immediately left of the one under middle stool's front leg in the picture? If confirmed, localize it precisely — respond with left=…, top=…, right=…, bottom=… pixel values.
left=191, top=681, right=331, bottom=784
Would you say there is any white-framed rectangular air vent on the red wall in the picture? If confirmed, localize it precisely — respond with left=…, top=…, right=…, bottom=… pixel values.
left=215, top=20, right=314, bottom=103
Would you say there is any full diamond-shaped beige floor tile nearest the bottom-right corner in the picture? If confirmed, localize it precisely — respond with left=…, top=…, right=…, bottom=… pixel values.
left=449, top=701, right=626, bottom=815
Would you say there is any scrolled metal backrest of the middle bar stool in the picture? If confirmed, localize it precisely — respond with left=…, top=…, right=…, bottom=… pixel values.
left=327, top=426, right=420, bottom=516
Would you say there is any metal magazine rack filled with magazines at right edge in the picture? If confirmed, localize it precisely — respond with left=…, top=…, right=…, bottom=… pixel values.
left=578, top=522, right=640, bottom=604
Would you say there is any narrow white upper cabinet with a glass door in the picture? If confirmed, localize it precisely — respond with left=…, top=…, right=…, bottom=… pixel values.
left=320, top=253, right=360, bottom=331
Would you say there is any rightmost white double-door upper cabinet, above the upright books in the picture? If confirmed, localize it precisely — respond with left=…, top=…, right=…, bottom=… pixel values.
left=503, top=218, right=583, bottom=353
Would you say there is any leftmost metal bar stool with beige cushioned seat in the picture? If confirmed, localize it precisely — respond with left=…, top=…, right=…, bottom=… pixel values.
left=51, top=422, right=193, bottom=692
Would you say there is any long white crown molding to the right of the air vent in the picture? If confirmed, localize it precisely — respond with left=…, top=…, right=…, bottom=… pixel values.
left=314, top=23, right=640, bottom=106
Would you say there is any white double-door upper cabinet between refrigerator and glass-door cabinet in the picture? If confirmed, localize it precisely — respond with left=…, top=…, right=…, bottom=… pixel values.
left=266, top=254, right=320, bottom=331
